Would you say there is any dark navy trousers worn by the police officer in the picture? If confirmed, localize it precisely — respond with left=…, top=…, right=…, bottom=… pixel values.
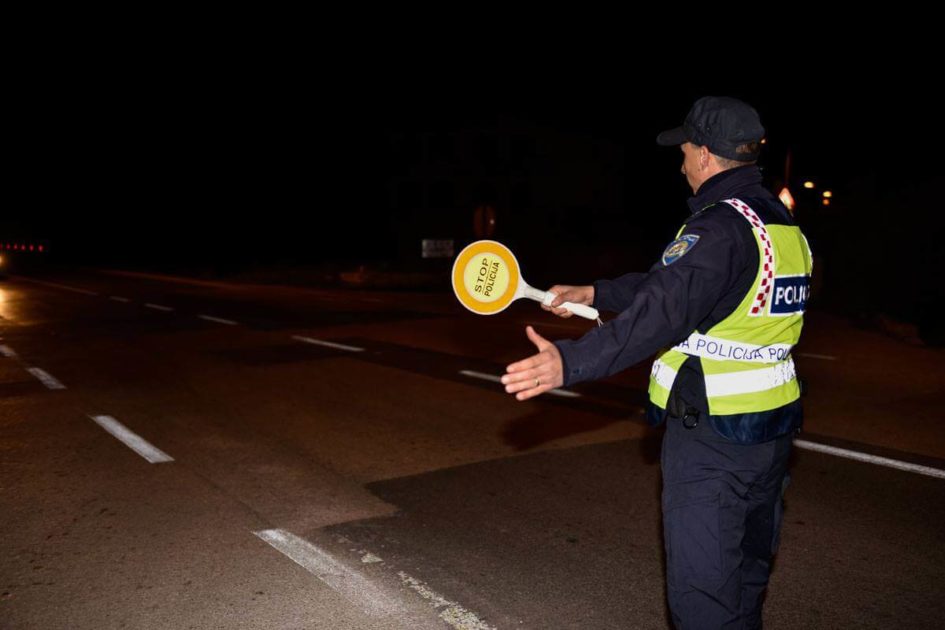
left=662, top=418, right=793, bottom=630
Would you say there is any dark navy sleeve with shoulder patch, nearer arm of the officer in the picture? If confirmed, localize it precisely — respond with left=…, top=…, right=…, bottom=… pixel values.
left=554, top=209, right=755, bottom=385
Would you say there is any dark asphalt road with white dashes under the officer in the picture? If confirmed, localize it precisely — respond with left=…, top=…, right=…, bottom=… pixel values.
left=0, top=270, right=945, bottom=630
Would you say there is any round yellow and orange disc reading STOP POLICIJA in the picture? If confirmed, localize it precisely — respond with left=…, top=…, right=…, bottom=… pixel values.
left=453, top=241, right=521, bottom=315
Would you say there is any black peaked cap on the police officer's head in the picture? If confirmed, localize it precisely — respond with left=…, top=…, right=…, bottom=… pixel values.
left=656, top=96, right=765, bottom=162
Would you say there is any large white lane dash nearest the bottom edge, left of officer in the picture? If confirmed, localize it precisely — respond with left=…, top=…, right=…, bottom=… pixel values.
left=253, top=529, right=403, bottom=617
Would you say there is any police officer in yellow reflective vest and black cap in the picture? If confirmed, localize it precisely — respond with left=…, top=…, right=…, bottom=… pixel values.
left=502, top=97, right=812, bottom=629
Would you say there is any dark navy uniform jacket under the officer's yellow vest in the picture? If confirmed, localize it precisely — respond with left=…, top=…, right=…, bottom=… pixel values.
left=554, top=165, right=801, bottom=444
